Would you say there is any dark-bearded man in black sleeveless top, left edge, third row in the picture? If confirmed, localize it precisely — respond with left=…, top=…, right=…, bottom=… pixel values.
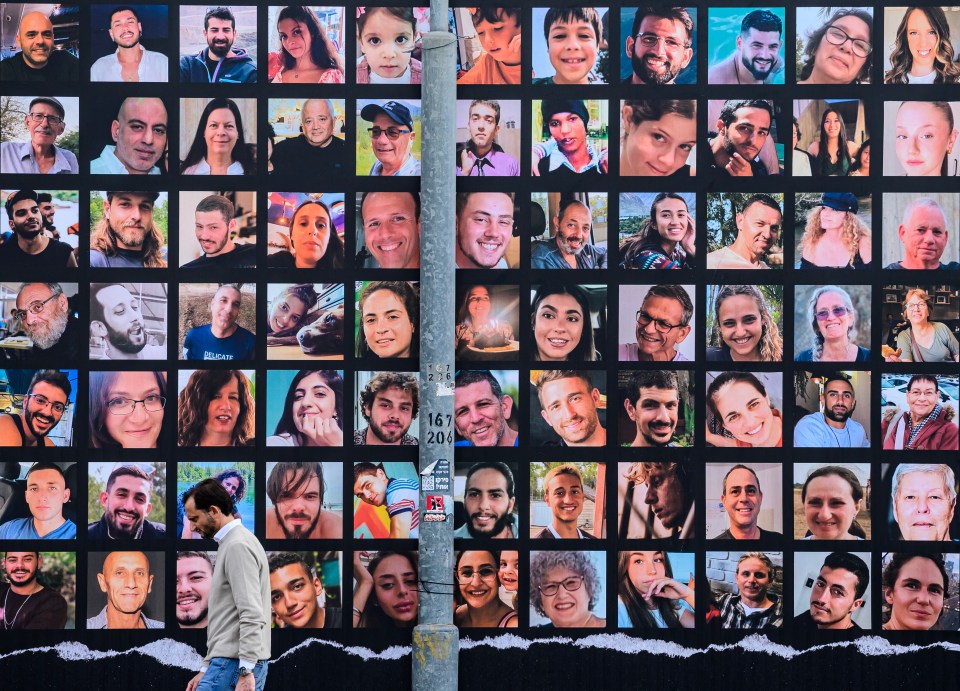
left=0, top=190, right=77, bottom=269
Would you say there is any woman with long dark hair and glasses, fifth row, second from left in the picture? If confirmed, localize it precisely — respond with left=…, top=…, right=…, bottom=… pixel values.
left=90, top=372, right=167, bottom=449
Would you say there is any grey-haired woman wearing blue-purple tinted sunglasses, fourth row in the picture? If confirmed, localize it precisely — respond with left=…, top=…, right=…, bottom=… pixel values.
left=796, top=286, right=870, bottom=362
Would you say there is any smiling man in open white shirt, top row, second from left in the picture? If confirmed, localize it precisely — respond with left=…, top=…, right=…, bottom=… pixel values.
left=90, top=6, right=168, bottom=82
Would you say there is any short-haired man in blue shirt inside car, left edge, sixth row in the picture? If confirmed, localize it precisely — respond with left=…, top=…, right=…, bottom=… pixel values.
left=0, top=462, right=77, bottom=540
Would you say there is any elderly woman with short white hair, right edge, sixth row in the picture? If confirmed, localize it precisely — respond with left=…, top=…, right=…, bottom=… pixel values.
left=890, top=463, right=957, bottom=542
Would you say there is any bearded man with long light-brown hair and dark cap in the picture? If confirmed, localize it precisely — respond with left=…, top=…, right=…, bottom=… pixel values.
left=90, top=192, right=167, bottom=269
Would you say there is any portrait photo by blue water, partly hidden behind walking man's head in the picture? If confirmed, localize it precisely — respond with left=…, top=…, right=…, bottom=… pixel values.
left=176, top=461, right=258, bottom=540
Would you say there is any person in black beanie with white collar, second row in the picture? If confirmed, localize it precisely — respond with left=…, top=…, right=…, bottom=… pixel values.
left=533, top=99, right=607, bottom=183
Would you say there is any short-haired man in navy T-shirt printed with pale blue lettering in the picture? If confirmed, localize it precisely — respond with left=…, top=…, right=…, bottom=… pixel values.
left=183, top=283, right=257, bottom=360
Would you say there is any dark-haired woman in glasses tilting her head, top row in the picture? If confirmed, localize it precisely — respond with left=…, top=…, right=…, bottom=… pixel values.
left=797, top=8, right=873, bottom=84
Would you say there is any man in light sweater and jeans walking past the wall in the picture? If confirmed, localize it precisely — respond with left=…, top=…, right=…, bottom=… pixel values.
left=183, top=479, right=270, bottom=691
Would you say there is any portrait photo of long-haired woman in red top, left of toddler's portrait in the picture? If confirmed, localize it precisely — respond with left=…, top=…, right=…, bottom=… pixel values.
left=266, top=5, right=347, bottom=84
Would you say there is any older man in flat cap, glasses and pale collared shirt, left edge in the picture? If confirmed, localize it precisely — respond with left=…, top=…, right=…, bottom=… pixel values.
left=0, top=96, right=80, bottom=175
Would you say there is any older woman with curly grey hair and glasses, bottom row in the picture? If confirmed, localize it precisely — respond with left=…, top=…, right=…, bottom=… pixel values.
left=530, top=552, right=607, bottom=629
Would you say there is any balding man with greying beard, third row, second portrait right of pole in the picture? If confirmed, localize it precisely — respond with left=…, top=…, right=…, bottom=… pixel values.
left=530, top=199, right=607, bottom=269
